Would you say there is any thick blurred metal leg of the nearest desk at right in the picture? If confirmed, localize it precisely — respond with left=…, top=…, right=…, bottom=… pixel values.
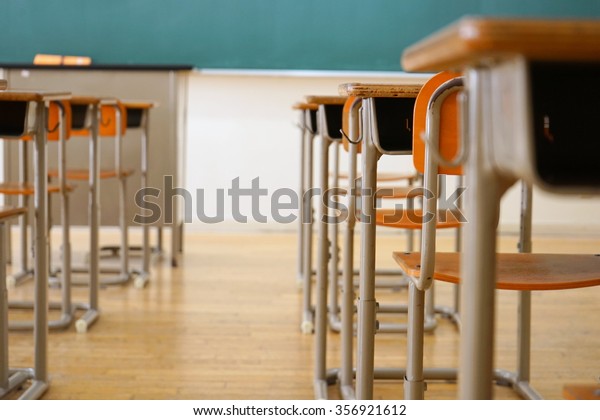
left=459, top=68, right=502, bottom=399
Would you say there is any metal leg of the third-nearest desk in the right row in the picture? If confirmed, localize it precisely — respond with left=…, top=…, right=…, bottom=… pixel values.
left=314, top=105, right=331, bottom=399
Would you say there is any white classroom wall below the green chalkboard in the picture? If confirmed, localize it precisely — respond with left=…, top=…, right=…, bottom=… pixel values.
left=186, top=71, right=600, bottom=233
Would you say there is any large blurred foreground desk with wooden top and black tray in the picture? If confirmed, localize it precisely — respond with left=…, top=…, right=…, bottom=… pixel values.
left=402, top=17, right=600, bottom=399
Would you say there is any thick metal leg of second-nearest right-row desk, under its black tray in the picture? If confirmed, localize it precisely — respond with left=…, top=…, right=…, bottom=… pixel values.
left=356, top=99, right=379, bottom=400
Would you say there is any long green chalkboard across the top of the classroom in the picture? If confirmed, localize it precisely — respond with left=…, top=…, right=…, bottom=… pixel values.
left=0, top=0, right=600, bottom=71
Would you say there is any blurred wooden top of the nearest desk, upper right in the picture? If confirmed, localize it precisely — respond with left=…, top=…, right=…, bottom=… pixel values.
left=402, top=17, right=600, bottom=71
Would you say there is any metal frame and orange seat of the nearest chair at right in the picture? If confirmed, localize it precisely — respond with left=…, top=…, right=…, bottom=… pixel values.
left=394, top=69, right=600, bottom=399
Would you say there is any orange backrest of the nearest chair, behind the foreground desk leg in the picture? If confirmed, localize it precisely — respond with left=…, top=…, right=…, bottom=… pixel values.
left=413, top=72, right=462, bottom=175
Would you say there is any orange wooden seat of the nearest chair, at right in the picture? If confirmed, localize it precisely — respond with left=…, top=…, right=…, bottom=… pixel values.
left=394, top=252, right=600, bottom=291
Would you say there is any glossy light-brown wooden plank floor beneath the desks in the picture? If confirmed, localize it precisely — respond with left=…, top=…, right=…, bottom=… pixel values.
left=9, top=228, right=600, bottom=400
